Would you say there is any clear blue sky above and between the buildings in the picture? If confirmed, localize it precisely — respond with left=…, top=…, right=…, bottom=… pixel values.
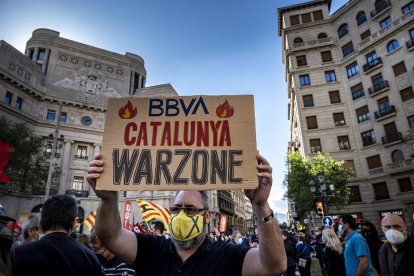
left=0, top=0, right=347, bottom=220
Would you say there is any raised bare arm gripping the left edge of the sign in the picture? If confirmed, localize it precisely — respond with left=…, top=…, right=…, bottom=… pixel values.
left=86, top=154, right=138, bottom=264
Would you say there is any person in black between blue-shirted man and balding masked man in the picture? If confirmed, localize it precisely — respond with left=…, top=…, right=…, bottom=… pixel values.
left=360, top=220, right=383, bottom=275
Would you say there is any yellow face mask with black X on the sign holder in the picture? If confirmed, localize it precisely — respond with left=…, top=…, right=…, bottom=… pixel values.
left=170, top=210, right=203, bottom=241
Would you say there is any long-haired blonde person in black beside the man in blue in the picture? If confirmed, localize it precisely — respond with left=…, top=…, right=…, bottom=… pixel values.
left=322, top=229, right=346, bottom=276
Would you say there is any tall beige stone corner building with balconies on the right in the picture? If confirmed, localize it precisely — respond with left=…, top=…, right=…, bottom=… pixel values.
left=278, top=0, right=414, bottom=229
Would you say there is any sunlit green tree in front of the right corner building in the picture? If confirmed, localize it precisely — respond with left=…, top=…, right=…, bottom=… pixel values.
left=283, top=152, right=351, bottom=213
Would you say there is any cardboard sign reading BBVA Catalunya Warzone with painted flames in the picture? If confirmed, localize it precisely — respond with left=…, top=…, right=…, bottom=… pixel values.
left=97, top=95, right=258, bottom=191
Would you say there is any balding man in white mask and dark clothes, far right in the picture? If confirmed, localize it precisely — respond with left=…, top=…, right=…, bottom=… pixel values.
left=379, top=214, right=414, bottom=276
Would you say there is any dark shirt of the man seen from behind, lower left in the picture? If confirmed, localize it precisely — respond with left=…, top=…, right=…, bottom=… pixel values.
left=11, top=232, right=105, bottom=276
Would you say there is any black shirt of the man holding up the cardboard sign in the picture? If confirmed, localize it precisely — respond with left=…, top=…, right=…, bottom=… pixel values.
left=132, top=234, right=250, bottom=276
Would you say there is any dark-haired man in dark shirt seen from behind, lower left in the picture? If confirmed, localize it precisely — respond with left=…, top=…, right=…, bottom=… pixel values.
left=11, top=195, right=105, bottom=276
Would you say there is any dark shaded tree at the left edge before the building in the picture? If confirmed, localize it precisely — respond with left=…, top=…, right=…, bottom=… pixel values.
left=0, top=117, right=59, bottom=195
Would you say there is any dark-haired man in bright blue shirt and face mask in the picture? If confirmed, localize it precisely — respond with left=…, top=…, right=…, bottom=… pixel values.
left=338, top=214, right=372, bottom=276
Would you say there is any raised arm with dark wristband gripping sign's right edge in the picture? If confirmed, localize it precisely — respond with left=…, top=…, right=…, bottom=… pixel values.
left=242, top=154, right=287, bottom=275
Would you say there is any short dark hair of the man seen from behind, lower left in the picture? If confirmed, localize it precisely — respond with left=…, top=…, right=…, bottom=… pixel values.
left=40, top=195, right=78, bottom=233
